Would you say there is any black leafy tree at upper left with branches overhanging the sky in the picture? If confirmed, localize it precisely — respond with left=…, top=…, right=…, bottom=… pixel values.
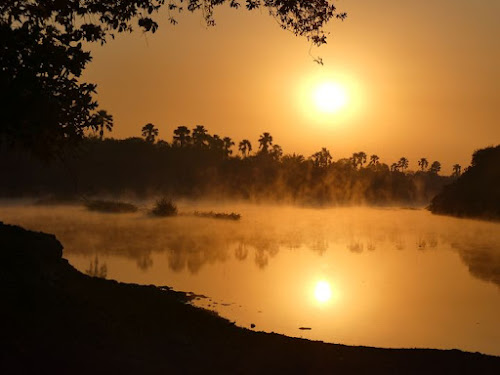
left=0, top=0, right=346, bottom=157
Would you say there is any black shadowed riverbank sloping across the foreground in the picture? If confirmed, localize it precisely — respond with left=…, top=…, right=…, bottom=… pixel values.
left=0, top=222, right=500, bottom=374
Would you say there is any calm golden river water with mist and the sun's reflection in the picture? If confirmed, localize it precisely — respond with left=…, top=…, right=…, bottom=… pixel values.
left=0, top=204, right=500, bottom=355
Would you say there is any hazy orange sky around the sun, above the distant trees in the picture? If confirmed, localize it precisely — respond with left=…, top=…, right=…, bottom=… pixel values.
left=85, top=0, right=500, bottom=173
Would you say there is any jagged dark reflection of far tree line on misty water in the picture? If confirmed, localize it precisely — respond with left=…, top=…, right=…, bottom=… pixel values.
left=2, top=207, right=500, bottom=286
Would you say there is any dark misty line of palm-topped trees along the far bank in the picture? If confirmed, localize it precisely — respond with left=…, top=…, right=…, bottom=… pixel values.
left=0, top=125, right=461, bottom=204
